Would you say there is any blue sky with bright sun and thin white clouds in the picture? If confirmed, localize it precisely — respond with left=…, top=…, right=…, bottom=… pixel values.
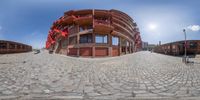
left=0, top=0, right=200, bottom=48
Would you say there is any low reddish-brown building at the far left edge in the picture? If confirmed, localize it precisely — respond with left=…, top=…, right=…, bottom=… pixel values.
left=0, top=40, right=32, bottom=54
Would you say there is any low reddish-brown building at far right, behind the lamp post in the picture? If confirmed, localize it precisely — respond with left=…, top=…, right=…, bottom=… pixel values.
left=154, top=40, right=200, bottom=55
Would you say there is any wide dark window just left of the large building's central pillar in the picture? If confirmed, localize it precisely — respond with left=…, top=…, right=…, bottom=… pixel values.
left=79, top=34, right=92, bottom=43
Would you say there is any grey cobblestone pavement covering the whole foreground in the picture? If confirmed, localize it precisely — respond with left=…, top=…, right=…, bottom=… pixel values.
left=0, top=51, right=200, bottom=100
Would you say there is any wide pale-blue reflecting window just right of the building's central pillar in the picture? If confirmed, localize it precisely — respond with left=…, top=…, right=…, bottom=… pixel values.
left=95, top=34, right=108, bottom=43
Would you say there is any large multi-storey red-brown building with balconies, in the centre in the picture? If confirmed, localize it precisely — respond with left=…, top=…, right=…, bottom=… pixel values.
left=46, top=9, right=142, bottom=57
